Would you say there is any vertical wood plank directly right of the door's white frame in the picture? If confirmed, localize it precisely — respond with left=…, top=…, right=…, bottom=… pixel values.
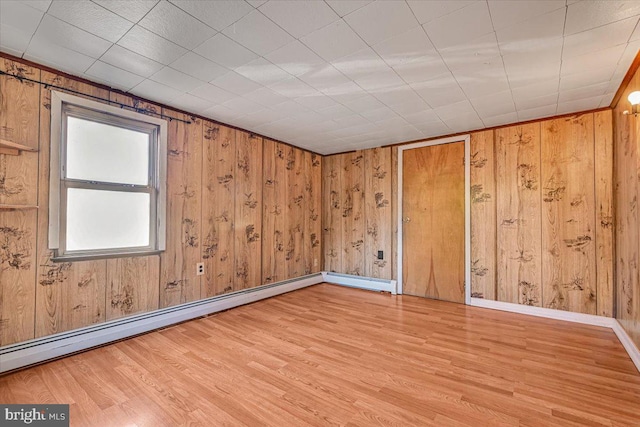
left=471, top=130, right=496, bottom=300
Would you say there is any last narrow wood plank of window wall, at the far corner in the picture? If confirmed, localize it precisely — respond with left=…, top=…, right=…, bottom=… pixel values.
left=304, top=151, right=322, bottom=274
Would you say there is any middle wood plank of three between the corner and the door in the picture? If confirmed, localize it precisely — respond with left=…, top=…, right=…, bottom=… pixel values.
left=342, top=151, right=365, bottom=276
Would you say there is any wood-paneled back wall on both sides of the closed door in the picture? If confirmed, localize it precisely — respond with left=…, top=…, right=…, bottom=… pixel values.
left=323, top=111, right=616, bottom=317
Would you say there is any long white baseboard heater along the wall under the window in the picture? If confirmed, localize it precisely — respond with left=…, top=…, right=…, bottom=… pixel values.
left=0, top=273, right=324, bottom=373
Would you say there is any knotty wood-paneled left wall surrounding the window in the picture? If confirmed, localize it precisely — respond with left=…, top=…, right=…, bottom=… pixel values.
left=0, top=58, right=322, bottom=346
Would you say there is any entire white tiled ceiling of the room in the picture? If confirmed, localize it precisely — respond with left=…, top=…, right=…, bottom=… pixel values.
left=0, top=0, right=640, bottom=154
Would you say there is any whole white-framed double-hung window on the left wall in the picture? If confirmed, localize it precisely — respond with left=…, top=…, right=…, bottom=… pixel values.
left=49, top=91, right=167, bottom=260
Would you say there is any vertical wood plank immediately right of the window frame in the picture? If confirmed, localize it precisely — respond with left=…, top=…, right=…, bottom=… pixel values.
left=160, top=109, right=202, bottom=307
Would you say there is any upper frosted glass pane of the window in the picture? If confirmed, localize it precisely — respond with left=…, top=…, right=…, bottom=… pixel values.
left=67, top=117, right=149, bottom=185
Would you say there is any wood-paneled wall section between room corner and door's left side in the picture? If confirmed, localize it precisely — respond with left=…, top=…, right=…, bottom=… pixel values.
left=322, top=147, right=393, bottom=279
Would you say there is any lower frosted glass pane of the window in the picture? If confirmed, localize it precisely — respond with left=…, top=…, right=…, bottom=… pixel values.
left=67, top=188, right=151, bottom=251
